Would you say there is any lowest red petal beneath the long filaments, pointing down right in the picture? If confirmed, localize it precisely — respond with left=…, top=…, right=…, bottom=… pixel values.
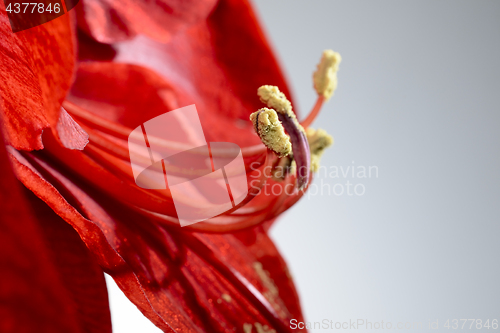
left=10, top=147, right=308, bottom=332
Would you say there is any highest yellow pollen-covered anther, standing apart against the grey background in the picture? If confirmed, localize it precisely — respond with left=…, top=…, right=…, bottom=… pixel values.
left=313, top=50, right=342, bottom=100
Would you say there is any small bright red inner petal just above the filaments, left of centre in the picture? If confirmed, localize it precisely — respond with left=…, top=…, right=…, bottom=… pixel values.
left=68, top=62, right=183, bottom=129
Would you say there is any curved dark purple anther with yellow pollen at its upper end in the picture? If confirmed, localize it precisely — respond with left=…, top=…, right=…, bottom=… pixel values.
left=257, top=85, right=311, bottom=190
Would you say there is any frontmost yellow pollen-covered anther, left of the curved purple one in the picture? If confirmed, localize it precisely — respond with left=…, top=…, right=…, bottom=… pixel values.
left=250, top=108, right=292, bottom=157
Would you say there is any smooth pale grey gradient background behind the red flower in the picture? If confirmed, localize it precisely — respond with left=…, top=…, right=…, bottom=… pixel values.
left=110, top=0, right=500, bottom=333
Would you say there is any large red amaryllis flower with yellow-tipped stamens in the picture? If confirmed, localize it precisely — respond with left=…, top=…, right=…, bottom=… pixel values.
left=0, top=0, right=340, bottom=333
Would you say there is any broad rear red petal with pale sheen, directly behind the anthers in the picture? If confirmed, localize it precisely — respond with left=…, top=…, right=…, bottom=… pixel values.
left=113, top=0, right=290, bottom=142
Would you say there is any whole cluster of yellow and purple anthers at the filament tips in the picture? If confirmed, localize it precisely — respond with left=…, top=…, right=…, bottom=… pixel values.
left=250, top=50, right=341, bottom=190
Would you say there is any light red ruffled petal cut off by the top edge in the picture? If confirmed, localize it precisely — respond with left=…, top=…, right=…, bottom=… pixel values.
left=76, top=0, right=217, bottom=43
